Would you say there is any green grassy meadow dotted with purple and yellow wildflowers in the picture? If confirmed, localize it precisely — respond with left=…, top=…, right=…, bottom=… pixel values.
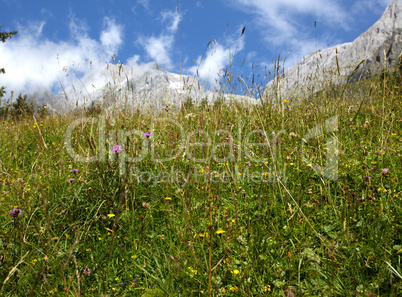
left=0, top=61, right=402, bottom=297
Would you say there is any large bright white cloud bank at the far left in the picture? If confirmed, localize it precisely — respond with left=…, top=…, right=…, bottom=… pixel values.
left=0, top=18, right=122, bottom=97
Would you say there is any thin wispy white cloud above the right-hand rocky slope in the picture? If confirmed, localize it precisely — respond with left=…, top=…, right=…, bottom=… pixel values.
left=223, top=0, right=351, bottom=66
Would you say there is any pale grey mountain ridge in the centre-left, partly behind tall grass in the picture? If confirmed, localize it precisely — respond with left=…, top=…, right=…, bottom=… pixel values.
left=27, top=62, right=257, bottom=113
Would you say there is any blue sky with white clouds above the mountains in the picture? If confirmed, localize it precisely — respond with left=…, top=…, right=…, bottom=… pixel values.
left=0, top=0, right=391, bottom=97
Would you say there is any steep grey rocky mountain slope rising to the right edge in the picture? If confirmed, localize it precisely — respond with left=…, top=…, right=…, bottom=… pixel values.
left=264, top=0, right=402, bottom=102
